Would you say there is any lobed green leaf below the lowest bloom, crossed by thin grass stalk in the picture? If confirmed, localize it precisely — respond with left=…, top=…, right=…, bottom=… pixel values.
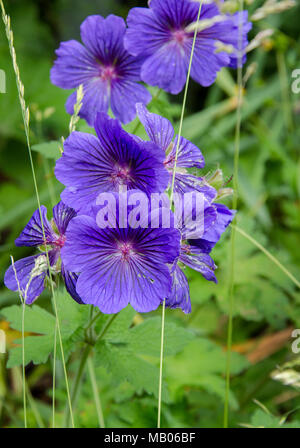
left=95, top=306, right=194, bottom=401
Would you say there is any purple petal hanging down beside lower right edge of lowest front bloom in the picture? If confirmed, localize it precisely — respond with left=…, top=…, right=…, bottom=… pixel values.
left=166, top=266, right=192, bottom=314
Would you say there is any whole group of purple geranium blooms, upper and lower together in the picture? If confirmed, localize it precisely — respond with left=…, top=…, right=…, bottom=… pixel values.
left=5, top=0, right=250, bottom=313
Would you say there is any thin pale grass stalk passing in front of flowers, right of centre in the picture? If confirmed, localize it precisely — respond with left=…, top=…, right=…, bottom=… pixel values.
left=157, top=0, right=203, bottom=428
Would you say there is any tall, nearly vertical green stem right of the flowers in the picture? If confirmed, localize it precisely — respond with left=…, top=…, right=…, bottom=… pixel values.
left=224, top=0, right=244, bottom=428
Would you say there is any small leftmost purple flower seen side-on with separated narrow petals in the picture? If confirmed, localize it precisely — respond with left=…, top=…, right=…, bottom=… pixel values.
left=4, top=202, right=82, bottom=305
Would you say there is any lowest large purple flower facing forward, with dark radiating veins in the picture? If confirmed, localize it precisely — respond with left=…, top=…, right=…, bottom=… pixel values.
left=62, top=194, right=180, bottom=314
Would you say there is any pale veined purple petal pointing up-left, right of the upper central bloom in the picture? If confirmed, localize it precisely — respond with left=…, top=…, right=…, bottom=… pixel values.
left=136, top=103, right=174, bottom=151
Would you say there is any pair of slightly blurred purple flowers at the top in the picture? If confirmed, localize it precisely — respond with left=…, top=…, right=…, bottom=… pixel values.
left=51, top=0, right=251, bottom=126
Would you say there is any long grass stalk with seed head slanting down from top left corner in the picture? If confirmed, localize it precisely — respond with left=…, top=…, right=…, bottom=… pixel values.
left=0, top=0, right=74, bottom=427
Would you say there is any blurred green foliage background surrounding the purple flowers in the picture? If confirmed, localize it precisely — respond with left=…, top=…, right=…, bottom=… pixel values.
left=0, top=0, right=300, bottom=427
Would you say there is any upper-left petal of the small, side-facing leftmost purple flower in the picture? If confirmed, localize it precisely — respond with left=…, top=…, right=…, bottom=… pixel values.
left=15, top=205, right=57, bottom=246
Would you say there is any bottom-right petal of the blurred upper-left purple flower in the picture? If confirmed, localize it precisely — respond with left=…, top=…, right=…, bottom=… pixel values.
left=111, top=79, right=151, bottom=123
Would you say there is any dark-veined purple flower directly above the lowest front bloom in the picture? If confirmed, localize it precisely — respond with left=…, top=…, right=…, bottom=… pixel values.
left=55, top=113, right=169, bottom=213
